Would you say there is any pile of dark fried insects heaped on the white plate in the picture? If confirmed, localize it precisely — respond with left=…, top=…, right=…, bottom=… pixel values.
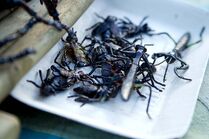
left=27, top=15, right=205, bottom=118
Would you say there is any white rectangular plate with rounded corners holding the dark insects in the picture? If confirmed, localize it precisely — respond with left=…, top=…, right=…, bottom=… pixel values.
left=12, top=0, right=209, bottom=139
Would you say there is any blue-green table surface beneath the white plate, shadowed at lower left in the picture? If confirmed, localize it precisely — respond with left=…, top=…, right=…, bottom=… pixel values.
left=0, top=0, right=209, bottom=139
